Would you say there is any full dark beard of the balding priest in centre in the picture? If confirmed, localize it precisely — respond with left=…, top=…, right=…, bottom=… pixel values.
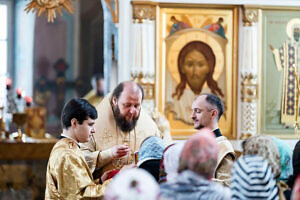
left=113, top=105, right=140, bottom=132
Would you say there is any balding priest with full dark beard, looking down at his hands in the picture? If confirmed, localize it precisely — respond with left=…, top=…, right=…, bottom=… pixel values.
left=82, top=81, right=159, bottom=176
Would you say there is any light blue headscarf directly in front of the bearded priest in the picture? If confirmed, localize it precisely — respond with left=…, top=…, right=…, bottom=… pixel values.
left=137, top=136, right=166, bottom=166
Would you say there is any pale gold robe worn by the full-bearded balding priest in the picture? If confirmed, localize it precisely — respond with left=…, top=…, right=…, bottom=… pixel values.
left=81, top=94, right=160, bottom=174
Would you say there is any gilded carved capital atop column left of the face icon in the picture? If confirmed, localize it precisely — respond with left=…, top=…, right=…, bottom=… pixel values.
left=133, top=4, right=155, bottom=23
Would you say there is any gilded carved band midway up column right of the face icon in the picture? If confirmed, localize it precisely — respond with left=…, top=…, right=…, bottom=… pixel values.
left=241, top=73, right=257, bottom=103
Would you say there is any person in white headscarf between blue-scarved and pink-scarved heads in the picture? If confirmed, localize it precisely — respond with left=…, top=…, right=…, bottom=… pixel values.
left=159, top=142, right=184, bottom=183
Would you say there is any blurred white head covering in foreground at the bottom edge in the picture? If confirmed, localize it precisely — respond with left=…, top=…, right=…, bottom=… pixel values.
left=104, top=168, right=159, bottom=200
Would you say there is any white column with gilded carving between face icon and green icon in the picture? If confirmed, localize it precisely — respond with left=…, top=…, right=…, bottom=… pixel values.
left=237, top=7, right=258, bottom=139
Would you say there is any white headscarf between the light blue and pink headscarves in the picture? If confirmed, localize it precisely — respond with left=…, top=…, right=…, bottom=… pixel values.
left=164, top=142, right=185, bottom=181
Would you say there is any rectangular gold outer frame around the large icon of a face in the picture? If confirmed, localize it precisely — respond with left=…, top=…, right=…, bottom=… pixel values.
left=155, top=4, right=239, bottom=139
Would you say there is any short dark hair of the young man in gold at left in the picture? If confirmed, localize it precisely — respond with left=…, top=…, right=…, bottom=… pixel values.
left=61, top=98, right=98, bottom=129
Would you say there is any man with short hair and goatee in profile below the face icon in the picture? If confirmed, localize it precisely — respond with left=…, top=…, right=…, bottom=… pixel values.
left=191, top=94, right=235, bottom=186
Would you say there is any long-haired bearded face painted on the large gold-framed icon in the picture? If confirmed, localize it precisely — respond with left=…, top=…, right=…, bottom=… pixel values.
left=172, top=41, right=223, bottom=99
